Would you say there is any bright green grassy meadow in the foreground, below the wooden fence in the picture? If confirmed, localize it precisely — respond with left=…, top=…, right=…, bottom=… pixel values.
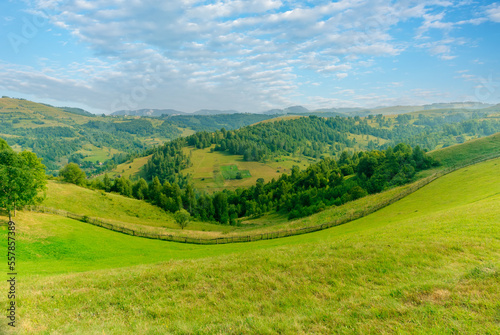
left=2, top=159, right=500, bottom=334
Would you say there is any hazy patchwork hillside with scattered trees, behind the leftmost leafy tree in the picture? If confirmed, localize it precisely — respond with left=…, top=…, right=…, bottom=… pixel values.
left=0, top=98, right=184, bottom=175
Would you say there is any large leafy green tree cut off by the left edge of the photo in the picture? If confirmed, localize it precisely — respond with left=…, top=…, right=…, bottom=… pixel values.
left=0, top=139, right=47, bottom=221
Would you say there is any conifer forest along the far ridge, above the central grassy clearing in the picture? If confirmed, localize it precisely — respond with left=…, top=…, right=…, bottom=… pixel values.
left=145, top=113, right=500, bottom=185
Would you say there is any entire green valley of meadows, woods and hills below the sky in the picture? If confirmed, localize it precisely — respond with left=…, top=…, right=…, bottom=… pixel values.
left=0, top=96, right=500, bottom=334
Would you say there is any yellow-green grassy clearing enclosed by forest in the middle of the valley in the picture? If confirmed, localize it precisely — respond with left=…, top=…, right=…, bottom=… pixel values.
left=182, top=147, right=315, bottom=192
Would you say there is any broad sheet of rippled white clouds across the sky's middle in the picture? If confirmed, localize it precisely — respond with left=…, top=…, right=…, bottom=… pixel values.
left=0, top=0, right=499, bottom=111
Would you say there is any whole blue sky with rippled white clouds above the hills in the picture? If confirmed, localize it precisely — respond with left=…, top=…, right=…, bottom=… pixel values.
left=0, top=0, right=500, bottom=113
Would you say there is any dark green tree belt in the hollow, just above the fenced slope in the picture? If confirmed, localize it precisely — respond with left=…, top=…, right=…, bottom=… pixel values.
left=80, top=141, right=438, bottom=225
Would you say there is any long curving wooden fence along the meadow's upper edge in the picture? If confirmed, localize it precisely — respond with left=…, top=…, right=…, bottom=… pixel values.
left=27, top=153, right=500, bottom=244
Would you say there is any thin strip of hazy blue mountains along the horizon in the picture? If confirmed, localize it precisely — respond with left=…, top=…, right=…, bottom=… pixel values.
left=111, top=101, right=494, bottom=117
